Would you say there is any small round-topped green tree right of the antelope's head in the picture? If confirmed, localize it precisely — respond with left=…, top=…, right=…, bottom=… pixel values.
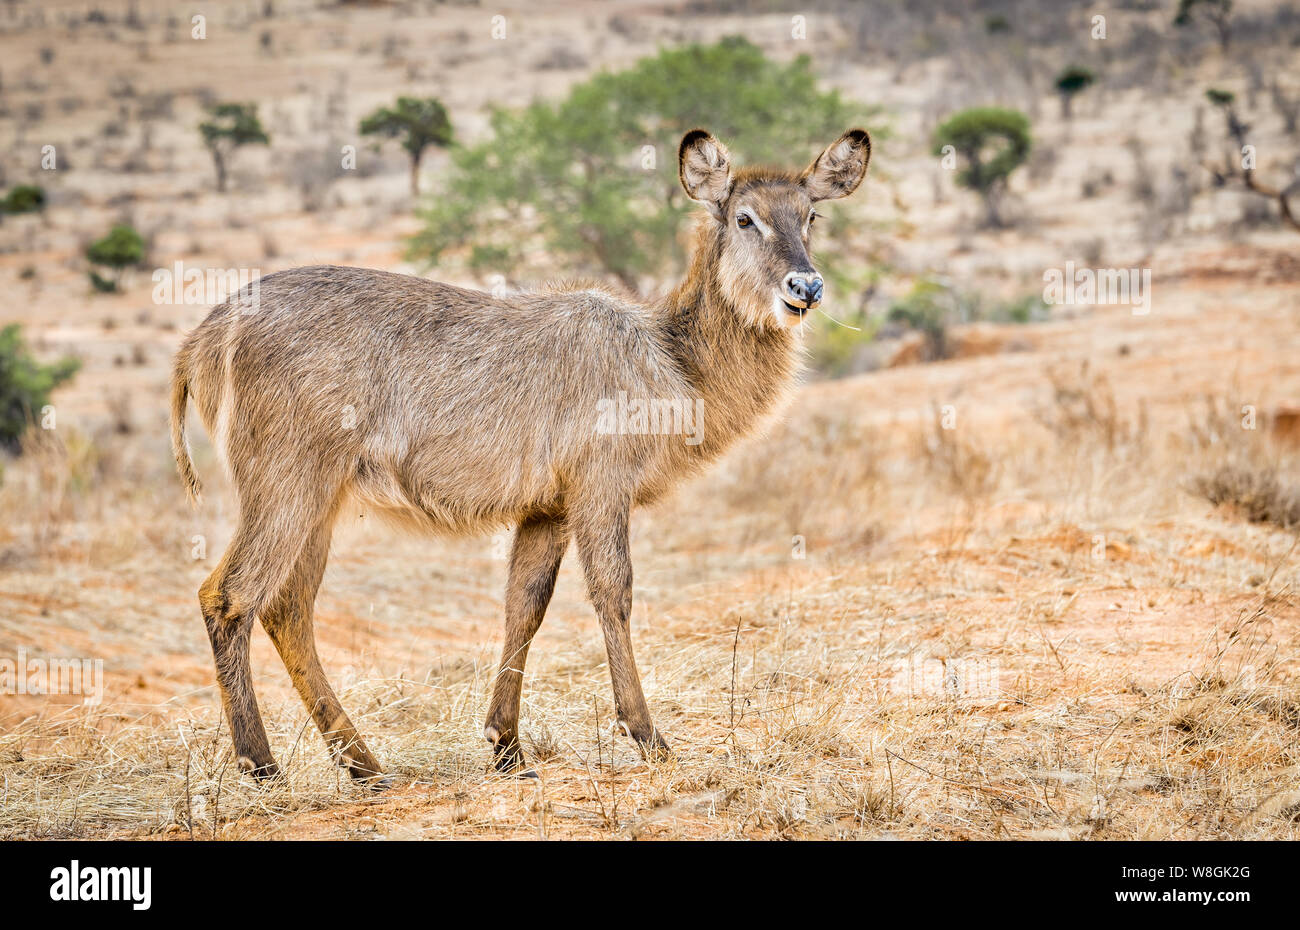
left=933, top=107, right=1032, bottom=226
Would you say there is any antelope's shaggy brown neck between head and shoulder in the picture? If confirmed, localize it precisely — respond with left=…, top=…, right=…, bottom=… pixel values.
left=657, top=242, right=800, bottom=459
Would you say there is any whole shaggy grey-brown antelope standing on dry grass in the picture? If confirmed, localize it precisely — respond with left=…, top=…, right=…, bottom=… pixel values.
left=172, top=129, right=871, bottom=788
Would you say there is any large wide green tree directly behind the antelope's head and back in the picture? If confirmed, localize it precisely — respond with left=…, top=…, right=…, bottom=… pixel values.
left=411, top=38, right=880, bottom=290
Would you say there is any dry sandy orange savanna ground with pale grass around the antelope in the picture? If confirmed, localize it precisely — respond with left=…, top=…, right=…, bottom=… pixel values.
left=0, top=3, right=1300, bottom=839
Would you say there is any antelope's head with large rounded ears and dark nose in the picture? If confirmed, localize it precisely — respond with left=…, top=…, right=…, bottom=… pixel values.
left=677, top=129, right=871, bottom=329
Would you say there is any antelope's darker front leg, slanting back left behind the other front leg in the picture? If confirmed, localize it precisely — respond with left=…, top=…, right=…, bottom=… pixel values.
left=484, top=518, right=568, bottom=778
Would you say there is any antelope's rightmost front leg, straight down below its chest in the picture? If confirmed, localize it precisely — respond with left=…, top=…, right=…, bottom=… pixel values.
left=575, top=503, right=671, bottom=760
